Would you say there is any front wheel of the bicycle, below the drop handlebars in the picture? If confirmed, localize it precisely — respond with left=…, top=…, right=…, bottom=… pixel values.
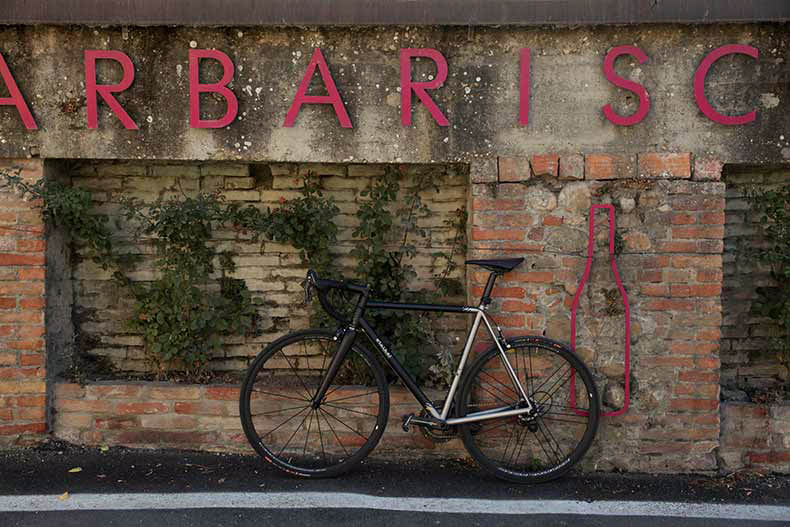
left=239, top=330, right=389, bottom=477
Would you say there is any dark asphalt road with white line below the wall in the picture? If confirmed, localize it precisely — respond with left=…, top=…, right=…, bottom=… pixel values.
left=0, top=443, right=790, bottom=527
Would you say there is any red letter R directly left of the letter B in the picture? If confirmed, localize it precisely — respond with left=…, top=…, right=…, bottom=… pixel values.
left=85, top=49, right=137, bottom=130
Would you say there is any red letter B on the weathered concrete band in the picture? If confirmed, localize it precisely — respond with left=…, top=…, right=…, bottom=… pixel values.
left=189, top=49, right=239, bottom=128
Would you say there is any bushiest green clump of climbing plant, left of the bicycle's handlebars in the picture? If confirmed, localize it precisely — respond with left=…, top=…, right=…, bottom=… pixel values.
left=123, top=194, right=257, bottom=380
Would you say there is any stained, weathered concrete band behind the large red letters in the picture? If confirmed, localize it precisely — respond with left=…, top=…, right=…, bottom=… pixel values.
left=0, top=24, right=790, bottom=163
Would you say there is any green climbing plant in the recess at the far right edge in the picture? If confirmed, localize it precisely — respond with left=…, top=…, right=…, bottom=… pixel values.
left=747, top=185, right=790, bottom=390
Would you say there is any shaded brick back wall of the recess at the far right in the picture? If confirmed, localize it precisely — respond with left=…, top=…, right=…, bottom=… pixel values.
left=721, top=167, right=790, bottom=398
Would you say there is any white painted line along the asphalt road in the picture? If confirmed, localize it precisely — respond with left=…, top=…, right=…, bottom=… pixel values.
left=0, top=492, right=790, bottom=521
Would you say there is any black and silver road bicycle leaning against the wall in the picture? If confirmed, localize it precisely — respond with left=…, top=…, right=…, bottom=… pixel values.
left=239, top=258, right=599, bottom=483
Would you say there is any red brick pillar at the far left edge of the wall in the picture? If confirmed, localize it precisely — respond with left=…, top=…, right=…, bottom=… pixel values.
left=0, top=160, right=46, bottom=447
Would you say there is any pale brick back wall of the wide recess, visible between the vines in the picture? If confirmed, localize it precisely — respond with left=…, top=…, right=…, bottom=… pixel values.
left=71, top=162, right=468, bottom=372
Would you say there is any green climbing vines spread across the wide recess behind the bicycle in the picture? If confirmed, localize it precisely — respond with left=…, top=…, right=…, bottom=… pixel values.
left=0, top=167, right=466, bottom=384
